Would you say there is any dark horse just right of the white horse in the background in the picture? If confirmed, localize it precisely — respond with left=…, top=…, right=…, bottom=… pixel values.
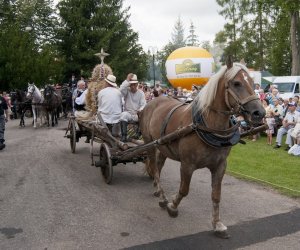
left=43, top=85, right=61, bottom=127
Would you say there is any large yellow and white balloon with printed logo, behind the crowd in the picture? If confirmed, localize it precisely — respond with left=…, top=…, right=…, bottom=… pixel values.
left=166, top=47, right=215, bottom=89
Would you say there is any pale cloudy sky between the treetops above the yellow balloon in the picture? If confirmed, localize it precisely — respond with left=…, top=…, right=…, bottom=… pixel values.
left=123, top=0, right=225, bottom=51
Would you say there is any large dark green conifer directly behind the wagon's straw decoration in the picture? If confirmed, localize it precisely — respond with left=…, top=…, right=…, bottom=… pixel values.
left=58, top=0, right=147, bottom=84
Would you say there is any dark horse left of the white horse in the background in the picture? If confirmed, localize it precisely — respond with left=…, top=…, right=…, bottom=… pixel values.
left=11, top=89, right=32, bottom=127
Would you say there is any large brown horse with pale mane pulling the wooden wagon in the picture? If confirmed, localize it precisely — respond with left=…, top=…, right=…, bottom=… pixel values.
left=140, top=60, right=265, bottom=238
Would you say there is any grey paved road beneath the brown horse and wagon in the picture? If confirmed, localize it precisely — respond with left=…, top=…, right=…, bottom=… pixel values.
left=0, top=120, right=300, bottom=250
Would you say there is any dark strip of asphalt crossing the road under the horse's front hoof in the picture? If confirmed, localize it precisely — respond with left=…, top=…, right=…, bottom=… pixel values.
left=126, top=209, right=300, bottom=250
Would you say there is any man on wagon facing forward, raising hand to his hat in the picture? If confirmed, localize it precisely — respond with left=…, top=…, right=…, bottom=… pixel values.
left=120, top=73, right=146, bottom=142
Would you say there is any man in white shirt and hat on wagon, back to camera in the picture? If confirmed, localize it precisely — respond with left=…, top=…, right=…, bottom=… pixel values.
left=98, top=75, right=122, bottom=136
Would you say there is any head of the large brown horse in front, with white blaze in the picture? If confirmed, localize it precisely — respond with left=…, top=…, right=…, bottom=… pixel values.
left=195, top=58, right=265, bottom=124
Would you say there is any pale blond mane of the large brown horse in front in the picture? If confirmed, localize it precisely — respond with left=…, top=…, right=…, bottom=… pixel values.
left=194, top=63, right=249, bottom=113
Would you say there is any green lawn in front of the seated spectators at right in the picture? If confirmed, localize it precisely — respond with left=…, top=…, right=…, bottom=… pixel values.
left=226, top=135, right=300, bottom=198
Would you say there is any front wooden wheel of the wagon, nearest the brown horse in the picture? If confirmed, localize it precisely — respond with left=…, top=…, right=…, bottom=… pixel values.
left=99, top=143, right=113, bottom=184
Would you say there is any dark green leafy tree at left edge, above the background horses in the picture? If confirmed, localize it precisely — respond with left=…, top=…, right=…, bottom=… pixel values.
left=0, top=0, right=60, bottom=89
